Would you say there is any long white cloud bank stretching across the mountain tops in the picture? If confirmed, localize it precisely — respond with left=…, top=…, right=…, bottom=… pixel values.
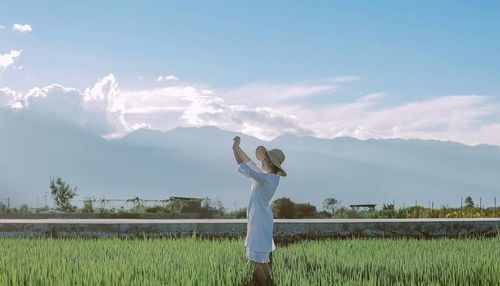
left=0, top=74, right=500, bottom=145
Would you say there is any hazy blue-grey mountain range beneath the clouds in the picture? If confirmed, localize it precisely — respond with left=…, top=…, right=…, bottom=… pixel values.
left=0, top=110, right=500, bottom=209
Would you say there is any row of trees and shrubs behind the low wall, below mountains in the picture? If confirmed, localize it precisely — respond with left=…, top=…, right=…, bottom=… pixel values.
left=0, top=174, right=500, bottom=219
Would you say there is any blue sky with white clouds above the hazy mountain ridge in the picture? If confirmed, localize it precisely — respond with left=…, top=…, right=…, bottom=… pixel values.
left=0, top=1, right=500, bottom=145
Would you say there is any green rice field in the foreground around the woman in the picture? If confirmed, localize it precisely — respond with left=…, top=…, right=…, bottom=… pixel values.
left=0, top=237, right=500, bottom=285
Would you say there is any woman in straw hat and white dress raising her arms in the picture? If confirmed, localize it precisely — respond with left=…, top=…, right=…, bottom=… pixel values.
left=233, top=136, right=286, bottom=285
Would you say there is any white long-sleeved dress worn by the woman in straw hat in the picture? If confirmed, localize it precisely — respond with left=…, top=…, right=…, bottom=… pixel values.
left=238, top=160, right=279, bottom=255
